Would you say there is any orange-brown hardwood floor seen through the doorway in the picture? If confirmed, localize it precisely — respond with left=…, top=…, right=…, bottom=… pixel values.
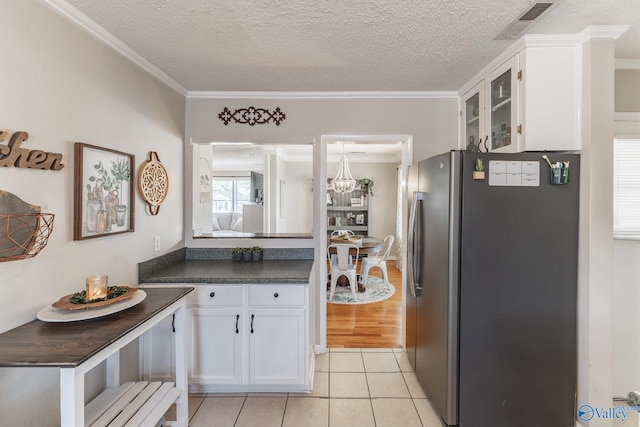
left=327, top=261, right=403, bottom=348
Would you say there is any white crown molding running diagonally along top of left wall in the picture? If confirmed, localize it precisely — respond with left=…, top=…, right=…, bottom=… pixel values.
left=42, top=0, right=187, bottom=96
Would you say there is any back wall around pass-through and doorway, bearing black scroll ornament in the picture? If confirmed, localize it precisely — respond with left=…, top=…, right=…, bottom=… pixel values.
left=185, top=94, right=458, bottom=247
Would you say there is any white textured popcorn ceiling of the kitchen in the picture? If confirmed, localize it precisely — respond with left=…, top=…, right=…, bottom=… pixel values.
left=57, top=0, right=640, bottom=91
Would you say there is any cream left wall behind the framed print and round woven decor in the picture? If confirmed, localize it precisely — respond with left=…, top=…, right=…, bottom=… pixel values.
left=0, top=0, right=184, bottom=427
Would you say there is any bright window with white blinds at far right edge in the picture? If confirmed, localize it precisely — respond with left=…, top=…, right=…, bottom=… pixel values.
left=613, top=138, right=640, bottom=239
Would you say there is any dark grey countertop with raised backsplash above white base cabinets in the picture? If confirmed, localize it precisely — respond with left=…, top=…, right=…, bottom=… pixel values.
left=138, top=248, right=313, bottom=284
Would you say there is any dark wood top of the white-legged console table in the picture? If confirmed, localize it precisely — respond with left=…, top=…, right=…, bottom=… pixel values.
left=0, top=287, right=193, bottom=367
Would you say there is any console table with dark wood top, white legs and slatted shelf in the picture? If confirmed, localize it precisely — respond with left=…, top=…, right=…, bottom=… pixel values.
left=0, top=287, right=193, bottom=427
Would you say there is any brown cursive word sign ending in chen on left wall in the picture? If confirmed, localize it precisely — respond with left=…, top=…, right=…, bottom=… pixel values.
left=0, top=131, right=64, bottom=171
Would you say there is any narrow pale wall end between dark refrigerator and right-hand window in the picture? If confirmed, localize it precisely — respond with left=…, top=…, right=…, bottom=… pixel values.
left=577, top=40, right=614, bottom=427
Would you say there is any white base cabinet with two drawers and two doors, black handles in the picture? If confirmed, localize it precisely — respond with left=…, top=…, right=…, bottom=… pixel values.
left=187, top=284, right=312, bottom=392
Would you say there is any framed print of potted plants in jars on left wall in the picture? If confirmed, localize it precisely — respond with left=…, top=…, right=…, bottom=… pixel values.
left=73, top=142, right=135, bottom=240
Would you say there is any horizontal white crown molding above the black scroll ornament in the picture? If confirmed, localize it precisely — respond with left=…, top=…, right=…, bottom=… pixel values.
left=187, top=91, right=458, bottom=99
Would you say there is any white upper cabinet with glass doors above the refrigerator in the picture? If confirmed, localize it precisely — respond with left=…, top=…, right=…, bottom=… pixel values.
left=460, top=45, right=581, bottom=153
